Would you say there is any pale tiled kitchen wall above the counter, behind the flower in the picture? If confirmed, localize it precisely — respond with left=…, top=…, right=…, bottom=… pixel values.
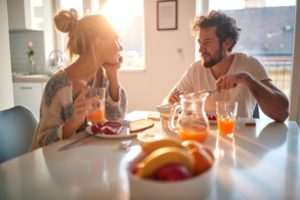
left=9, top=30, right=46, bottom=73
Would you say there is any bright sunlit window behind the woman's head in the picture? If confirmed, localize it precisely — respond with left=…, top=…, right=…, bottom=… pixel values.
left=56, top=0, right=144, bottom=70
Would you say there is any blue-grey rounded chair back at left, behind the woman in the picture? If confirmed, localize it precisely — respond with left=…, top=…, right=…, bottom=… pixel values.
left=0, top=106, right=37, bottom=163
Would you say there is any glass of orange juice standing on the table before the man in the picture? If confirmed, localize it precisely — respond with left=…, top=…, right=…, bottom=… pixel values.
left=216, top=101, right=238, bottom=136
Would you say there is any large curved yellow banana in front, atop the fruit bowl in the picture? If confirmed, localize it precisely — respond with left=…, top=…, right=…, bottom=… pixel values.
left=136, top=147, right=195, bottom=178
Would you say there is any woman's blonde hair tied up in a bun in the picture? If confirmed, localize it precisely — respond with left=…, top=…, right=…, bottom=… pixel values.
left=53, top=9, right=113, bottom=58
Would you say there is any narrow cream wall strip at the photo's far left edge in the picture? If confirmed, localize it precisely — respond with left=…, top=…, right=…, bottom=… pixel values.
left=0, top=0, right=14, bottom=110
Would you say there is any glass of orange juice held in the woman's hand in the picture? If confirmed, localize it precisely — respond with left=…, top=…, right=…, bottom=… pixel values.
left=87, top=87, right=106, bottom=125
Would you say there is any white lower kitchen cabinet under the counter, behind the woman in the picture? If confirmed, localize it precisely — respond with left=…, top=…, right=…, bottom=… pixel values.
left=13, top=82, right=45, bottom=119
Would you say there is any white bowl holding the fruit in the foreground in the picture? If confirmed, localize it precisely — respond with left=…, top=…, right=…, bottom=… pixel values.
left=127, top=145, right=216, bottom=200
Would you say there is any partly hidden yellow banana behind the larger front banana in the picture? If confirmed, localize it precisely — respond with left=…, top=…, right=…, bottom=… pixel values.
left=141, top=138, right=183, bottom=152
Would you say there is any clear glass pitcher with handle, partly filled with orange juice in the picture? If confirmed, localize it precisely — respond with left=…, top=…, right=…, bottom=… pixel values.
left=169, top=92, right=210, bottom=143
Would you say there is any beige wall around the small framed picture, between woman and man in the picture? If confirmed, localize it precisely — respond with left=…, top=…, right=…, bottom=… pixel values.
left=120, top=0, right=195, bottom=111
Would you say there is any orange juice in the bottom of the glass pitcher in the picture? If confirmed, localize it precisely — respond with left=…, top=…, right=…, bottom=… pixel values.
left=179, top=125, right=209, bottom=143
